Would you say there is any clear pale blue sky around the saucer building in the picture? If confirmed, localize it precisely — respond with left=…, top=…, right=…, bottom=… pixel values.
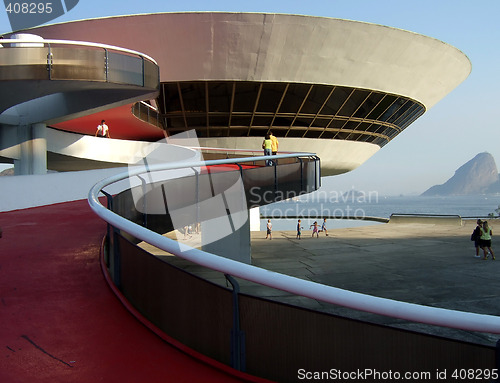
left=0, top=0, right=500, bottom=195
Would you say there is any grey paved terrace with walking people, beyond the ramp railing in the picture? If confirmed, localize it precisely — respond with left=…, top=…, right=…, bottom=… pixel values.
left=148, top=220, right=500, bottom=345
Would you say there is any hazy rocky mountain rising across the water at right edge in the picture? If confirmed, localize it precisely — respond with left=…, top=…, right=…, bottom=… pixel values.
left=422, top=152, right=500, bottom=196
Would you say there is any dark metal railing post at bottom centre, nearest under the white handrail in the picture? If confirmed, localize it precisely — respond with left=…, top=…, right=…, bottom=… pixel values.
left=224, top=274, right=246, bottom=372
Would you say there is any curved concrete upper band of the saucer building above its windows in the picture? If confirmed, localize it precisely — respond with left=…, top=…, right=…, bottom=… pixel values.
left=25, top=12, right=471, bottom=109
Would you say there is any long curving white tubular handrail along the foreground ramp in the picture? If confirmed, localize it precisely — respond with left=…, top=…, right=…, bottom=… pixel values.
left=88, top=153, right=500, bottom=334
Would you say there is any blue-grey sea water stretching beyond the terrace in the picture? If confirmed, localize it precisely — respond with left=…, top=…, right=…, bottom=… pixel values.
left=260, top=194, right=500, bottom=230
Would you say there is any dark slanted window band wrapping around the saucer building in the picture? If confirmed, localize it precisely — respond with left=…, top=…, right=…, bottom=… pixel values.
left=158, top=81, right=425, bottom=147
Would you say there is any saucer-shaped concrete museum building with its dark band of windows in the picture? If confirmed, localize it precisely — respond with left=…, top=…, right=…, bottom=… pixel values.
left=19, top=12, right=471, bottom=175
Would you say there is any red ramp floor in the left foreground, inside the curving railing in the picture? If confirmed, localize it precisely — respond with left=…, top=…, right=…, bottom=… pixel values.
left=0, top=201, right=264, bottom=383
